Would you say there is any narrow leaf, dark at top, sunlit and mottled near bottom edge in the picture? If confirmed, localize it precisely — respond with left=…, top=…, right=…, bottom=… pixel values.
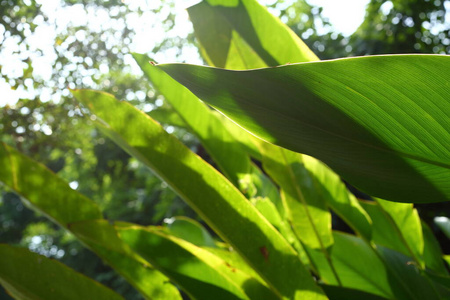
left=69, top=220, right=181, bottom=300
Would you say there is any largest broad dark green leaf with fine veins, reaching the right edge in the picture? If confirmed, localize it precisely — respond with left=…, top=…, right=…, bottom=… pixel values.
left=158, top=55, right=450, bottom=203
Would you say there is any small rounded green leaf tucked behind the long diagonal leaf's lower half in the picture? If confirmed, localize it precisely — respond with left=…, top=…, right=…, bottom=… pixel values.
left=167, top=217, right=215, bottom=247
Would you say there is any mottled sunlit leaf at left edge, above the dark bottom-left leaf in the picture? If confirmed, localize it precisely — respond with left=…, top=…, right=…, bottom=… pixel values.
left=0, top=143, right=102, bottom=227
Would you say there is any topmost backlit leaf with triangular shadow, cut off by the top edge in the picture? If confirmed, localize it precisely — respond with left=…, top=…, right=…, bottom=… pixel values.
left=188, top=0, right=318, bottom=69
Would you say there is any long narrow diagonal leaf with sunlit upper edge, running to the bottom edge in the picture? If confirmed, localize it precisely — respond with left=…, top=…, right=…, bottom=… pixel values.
left=73, top=90, right=325, bottom=299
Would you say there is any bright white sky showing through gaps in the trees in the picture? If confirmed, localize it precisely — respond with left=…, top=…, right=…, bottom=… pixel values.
left=0, top=0, right=369, bottom=107
